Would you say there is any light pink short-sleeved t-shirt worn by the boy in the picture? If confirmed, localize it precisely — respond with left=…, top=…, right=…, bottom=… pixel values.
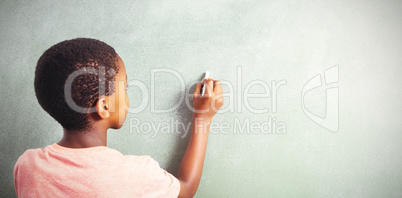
left=14, top=144, right=180, bottom=197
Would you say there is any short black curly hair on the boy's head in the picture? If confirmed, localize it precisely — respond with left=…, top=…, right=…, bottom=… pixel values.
left=34, top=38, right=118, bottom=131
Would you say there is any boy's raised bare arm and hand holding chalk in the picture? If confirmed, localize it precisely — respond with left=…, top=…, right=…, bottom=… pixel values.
left=177, top=78, right=224, bottom=197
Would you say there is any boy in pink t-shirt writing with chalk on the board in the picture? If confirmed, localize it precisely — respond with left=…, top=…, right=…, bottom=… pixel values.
left=14, top=38, right=223, bottom=197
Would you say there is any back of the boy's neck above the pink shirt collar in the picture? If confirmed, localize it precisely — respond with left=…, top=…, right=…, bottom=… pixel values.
left=57, top=128, right=107, bottom=148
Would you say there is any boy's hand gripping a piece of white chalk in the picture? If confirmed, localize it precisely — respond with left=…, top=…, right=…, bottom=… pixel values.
left=193, top=78, right=224, bottom=120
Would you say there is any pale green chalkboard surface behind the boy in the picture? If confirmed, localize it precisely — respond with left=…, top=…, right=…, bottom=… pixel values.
left=0, top=0, right=402, bottom=197
